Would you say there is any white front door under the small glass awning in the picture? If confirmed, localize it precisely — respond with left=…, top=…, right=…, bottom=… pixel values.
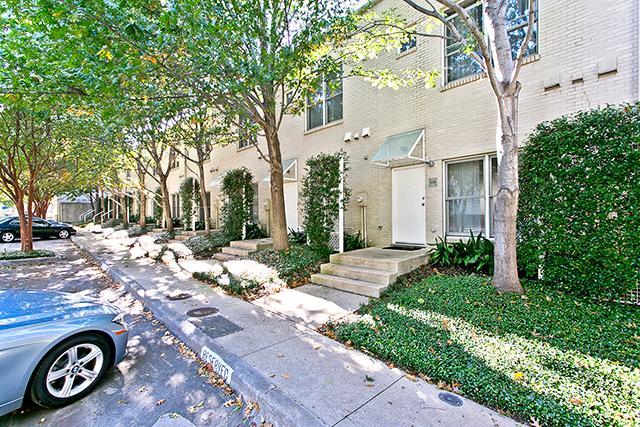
left=391, top=165, right=427, bottom=246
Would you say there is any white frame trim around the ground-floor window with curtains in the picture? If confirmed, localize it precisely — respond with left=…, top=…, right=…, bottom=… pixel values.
left=442, top=153, right=497, bottom=240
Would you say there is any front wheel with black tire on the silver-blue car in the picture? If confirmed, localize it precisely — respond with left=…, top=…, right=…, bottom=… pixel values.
left=31, top=334, right=112, bottom=408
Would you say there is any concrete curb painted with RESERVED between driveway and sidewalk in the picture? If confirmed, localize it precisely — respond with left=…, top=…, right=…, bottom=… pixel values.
left=71, top=238, right=327, bottom=426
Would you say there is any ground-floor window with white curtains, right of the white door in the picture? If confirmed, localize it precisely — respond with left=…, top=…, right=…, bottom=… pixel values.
left=445, top=155, right=498, bottom=237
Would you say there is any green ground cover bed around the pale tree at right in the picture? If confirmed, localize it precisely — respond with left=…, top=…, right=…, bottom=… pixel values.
left=330, top=276, right=640, bottom=426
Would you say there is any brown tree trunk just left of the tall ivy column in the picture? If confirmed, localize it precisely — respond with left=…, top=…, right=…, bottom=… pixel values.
left=265, top=130, right=289, bottom=251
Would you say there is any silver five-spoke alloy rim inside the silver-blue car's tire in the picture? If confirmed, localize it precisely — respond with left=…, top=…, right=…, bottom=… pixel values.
left=46, top=343, right=104, bottom=399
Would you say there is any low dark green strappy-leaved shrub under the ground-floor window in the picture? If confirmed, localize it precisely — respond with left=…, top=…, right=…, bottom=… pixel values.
left=429, top=231, right=493, bottom=274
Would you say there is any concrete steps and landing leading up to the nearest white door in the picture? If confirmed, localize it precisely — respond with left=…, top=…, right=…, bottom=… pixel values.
left=311, top=248, right=429, bottom=298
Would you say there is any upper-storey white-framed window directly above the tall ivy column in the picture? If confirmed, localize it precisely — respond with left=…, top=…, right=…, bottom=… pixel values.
left=307, top=69, right=342, bottom=130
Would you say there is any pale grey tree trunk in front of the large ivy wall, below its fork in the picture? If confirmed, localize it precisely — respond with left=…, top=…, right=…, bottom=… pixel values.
left=493, top=92, right=524, bottom=293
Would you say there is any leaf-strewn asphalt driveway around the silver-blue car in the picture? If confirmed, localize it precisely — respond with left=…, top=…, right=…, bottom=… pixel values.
left=0, top=240, right=253, bottom=426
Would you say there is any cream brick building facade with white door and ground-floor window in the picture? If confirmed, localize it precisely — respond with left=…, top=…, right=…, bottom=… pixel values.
left=158, top=0, right=639, bottom=249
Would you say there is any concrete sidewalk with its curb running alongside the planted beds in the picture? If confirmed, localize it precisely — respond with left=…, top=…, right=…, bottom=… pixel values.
left=74, top=234, right=516, bottom=427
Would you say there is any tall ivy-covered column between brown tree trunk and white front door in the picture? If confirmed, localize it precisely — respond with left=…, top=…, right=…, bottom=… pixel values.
left=300, top=151, right=350, bottom=253
